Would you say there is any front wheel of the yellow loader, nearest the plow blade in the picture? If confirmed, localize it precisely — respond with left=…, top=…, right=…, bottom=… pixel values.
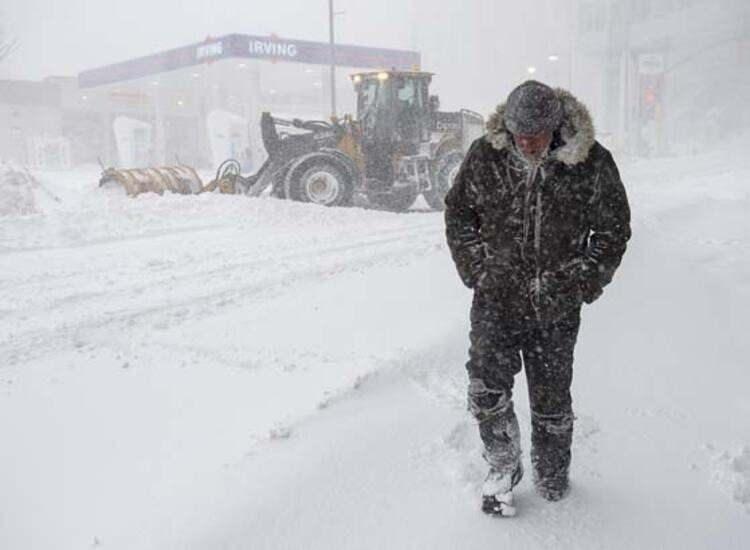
left=289, top=162, right=354, bottom=206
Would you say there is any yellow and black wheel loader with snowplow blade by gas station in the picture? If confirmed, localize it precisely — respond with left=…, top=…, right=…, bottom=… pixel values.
left=101, top=71, right=484, bottom=211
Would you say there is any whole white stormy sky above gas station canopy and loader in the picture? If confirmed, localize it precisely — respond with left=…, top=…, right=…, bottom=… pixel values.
left=0, top=0, right=571, bottom=110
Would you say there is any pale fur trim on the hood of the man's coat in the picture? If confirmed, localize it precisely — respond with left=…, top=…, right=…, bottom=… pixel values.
left=487, top=88, right=596, bottom=166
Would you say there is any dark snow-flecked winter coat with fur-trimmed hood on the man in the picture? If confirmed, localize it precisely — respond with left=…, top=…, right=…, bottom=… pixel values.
left=445, top=89, right=630, bottom=321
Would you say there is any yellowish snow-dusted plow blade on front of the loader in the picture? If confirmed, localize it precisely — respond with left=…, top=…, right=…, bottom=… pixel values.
left=99, top=166, right=203, bottom=197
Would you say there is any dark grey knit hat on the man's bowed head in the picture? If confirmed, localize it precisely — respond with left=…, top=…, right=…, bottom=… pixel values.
left=504, top=80, right=563, bottom=136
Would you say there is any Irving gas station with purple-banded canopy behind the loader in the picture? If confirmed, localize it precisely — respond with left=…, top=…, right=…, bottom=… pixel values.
left=0, top=34, right=420, bottom=171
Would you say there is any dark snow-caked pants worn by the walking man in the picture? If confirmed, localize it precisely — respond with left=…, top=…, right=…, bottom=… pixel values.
left=466, top=296, right=580, bottom=488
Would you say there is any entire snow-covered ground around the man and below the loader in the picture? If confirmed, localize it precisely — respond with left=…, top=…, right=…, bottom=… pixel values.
left=0, top=135, right=750, bottom=550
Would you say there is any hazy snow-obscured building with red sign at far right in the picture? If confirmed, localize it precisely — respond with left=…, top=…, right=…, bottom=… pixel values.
left=575, top=0, right=750, bottom=156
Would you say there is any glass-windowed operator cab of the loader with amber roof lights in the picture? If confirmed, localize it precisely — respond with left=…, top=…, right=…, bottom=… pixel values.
left=352, top=71, right=432, bottom=154
